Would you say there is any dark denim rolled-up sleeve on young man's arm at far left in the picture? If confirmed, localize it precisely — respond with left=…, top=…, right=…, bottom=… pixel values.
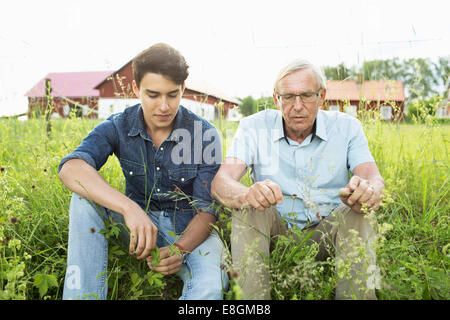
left=58, top=120, right=118, bottom=172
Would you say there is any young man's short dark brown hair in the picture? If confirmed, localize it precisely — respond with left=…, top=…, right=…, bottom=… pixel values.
left=132, top=43, right=189, bottom=88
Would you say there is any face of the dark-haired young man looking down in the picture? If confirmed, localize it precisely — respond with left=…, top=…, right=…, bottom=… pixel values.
left=133, top=72, right=185, bottom=132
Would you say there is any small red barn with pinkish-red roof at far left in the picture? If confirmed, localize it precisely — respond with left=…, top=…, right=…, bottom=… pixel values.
left=25, top=71, right=112, bottom=118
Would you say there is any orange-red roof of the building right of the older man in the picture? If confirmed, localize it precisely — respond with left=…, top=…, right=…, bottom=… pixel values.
left=326, top=80, right=405, bottom=101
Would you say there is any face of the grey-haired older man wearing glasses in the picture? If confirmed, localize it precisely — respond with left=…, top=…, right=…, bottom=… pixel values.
left=273, top=69, right=326, bottom=143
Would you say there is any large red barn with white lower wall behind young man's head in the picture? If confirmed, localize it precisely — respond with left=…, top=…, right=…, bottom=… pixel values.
left=95, top=61, right=240, bottom=120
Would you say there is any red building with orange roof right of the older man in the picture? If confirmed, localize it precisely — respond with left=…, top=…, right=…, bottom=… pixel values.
left=324, top=80, right=405, bottom=121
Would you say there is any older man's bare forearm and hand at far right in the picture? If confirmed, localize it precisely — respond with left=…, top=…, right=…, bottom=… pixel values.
left=339, top=162, right=384, bottom=212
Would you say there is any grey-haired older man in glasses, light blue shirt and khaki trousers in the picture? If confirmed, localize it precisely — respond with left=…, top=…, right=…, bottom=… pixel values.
left=212, top=60, right=384, bottom=299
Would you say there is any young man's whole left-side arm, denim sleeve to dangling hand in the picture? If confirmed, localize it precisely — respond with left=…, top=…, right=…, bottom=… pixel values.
left=58, top=119, right=157, bottom=259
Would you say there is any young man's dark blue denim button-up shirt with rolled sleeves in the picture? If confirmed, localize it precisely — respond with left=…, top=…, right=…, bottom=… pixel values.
left=58, top=104, right=222, bottom=234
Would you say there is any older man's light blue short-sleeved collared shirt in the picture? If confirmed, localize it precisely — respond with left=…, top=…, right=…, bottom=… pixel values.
left=227, top=109, right=375, bottom=229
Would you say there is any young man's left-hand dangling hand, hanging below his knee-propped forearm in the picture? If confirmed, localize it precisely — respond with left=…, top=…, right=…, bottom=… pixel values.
left=124, top=204, right=158, bottom=259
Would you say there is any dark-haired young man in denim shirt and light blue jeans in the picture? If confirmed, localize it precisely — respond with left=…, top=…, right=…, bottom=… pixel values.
left=58, top=43, right=228, bottom=299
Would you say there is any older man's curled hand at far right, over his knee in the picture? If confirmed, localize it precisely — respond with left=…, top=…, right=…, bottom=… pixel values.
left=339, top=176, right=384, bottom=213
